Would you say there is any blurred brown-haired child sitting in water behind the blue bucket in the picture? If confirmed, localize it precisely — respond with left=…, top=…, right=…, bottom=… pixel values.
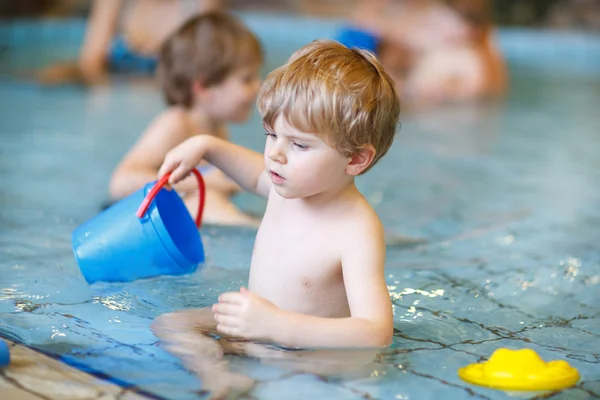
left=110, top=11, right=262, bottom=226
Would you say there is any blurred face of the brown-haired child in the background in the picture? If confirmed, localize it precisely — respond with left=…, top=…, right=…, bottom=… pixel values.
left=203, top=65, right=260, bottom=122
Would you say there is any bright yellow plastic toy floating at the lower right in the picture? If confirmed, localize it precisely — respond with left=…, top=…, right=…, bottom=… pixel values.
left=458, top=348, right=579, bottom=391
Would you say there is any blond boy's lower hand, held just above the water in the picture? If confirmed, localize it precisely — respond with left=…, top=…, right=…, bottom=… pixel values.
left=213, top=288, right=279, bottom=340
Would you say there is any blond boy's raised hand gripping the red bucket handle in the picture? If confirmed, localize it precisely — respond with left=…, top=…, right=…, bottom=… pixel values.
left=158, top=135, right=206, bottom=184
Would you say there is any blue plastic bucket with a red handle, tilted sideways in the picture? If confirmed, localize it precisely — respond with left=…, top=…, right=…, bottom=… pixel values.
left=72, top=170, right=205, bottom=283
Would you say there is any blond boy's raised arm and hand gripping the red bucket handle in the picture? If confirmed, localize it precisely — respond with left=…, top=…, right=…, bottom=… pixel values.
left=158, top=135, right=271, bottom=197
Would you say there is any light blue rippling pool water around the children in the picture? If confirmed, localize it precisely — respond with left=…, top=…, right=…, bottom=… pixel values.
left=0, top=14, right=600, bottom=400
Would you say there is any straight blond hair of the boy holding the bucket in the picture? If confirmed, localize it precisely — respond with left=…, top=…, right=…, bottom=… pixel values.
left=258, top=40, right=400, bottom=173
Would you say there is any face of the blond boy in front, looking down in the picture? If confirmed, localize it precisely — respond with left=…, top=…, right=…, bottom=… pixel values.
left=264, top=116, right=352, bottom=199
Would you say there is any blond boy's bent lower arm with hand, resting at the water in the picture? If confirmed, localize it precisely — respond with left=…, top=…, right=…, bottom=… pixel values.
left=214, top=214, right=393, bottom=347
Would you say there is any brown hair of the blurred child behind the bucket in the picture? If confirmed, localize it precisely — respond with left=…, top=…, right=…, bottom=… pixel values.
left=158, top=11, right=262, bottom=108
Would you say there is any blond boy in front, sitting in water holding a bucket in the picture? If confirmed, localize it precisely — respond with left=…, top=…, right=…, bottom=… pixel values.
left=153, top=41, right=400, bottom=396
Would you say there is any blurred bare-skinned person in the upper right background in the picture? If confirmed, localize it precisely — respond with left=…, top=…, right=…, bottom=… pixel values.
left=342, top=0, right=506, bottom=106
